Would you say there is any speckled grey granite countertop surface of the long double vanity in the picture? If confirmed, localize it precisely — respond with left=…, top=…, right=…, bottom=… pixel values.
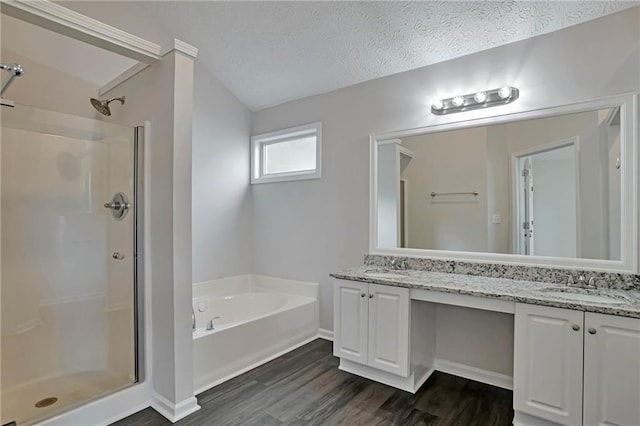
left=330, top=266, right=640, bottom=318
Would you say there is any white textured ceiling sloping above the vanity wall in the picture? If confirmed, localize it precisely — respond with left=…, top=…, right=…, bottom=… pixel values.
left=139, top=1, right=639, bottom=110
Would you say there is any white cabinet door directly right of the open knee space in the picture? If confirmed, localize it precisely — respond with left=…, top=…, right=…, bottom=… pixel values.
left=513, top=303, right=584, bottom=425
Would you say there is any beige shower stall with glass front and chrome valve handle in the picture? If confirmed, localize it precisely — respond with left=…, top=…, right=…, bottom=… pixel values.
left=0, top=104, right=143, bottom=425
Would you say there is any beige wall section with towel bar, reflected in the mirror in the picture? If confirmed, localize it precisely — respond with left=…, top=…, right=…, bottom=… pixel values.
left=402, top=127, right=488, bottom=252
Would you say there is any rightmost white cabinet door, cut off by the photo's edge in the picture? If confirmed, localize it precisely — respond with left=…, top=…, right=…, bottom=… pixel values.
left=584, top=313, right=640, bottom=426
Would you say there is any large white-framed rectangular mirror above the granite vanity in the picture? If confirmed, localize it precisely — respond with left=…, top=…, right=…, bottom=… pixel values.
left=372, top=97, right=636, bottom=268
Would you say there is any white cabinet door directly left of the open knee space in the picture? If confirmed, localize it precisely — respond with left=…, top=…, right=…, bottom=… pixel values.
left=369, top=284, right=409, bottom=377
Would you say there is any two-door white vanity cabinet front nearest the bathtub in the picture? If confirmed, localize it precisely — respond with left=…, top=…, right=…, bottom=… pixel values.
left=333, top=279, right=410, bottom=377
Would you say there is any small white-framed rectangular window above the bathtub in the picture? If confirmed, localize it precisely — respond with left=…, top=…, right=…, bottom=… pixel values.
left=251, top=122, right=322, bottom=183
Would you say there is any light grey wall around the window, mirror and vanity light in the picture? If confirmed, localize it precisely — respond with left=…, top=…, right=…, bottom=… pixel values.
left=252, top=8, right=640, bottom=329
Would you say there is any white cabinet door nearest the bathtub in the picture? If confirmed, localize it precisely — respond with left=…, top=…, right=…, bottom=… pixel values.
left=333, top=280, right=369, bottom=364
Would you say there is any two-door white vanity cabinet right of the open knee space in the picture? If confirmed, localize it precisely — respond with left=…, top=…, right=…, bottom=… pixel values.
left=513, top=304, right=640, bottom=425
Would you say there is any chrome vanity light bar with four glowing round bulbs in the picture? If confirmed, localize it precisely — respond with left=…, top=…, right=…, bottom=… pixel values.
left=431, top=86, right=520, bottom=115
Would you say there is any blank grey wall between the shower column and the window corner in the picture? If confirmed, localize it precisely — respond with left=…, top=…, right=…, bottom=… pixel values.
left=192, top=62, right=252, bottom=282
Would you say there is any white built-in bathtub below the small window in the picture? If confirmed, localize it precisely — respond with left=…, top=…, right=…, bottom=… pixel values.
left=193, top=275, right=318, bottom=394
